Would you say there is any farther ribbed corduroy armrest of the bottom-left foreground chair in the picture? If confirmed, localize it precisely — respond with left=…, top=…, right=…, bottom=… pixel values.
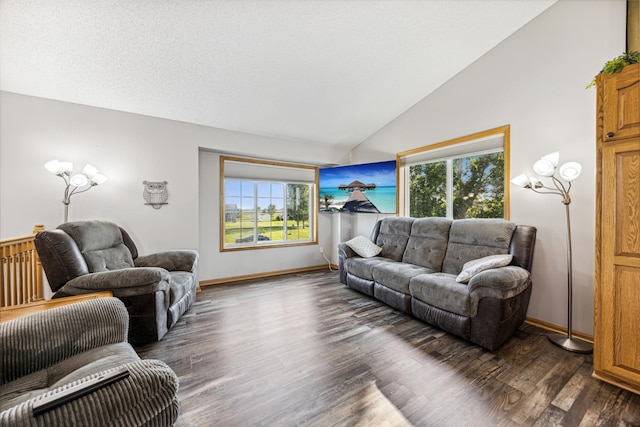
left=0, top=298, right=129, bottom=384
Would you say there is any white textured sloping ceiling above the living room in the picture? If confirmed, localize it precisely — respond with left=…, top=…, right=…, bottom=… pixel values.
left=0, top=0, right=556, bottom=148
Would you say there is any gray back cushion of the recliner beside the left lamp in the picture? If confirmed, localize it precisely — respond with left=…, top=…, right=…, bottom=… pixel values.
left=58, top=221, right=134, bottom=273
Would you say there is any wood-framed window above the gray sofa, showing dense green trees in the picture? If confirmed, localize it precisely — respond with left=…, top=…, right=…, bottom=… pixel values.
left=398, top=126, right=509, bottom=219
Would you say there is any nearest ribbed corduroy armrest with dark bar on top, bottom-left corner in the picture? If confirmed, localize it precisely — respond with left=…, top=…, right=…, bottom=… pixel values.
left=0, top=360, right=178, bottom=426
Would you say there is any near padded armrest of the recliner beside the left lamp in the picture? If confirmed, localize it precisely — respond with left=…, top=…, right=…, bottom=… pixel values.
left=59, top=267, right=171, bottom=297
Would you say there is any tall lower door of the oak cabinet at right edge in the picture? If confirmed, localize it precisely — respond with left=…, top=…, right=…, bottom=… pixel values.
left=594, top=138, right=640, bottom=387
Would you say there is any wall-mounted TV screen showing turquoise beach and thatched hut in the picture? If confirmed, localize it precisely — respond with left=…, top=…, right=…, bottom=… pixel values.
left=319, top=160, right=396, bottom=213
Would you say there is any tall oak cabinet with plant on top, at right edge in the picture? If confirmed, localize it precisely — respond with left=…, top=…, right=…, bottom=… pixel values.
left=593, top=64, right=640, bottom=394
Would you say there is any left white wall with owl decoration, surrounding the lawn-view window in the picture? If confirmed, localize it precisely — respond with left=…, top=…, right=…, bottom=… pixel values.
left=0, top=92, right=346, bottom=280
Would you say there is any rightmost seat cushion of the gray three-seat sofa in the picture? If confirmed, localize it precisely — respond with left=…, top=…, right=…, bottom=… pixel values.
left=409, top=273, right=475, bottom=317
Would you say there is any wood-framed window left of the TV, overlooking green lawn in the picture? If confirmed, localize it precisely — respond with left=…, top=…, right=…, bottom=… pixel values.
left=220, top=156, right=317, bottom=250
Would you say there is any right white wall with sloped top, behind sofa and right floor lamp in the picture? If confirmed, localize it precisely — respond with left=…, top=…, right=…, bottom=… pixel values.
left=344, top=1, right=625, bottom=334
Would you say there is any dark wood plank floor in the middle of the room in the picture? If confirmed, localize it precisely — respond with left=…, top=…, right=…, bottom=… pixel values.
left=136, top=271, right=640, bottom=426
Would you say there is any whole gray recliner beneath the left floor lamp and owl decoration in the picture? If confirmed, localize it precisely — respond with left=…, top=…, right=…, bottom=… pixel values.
left=35, top=221, right=198, bottom=343
